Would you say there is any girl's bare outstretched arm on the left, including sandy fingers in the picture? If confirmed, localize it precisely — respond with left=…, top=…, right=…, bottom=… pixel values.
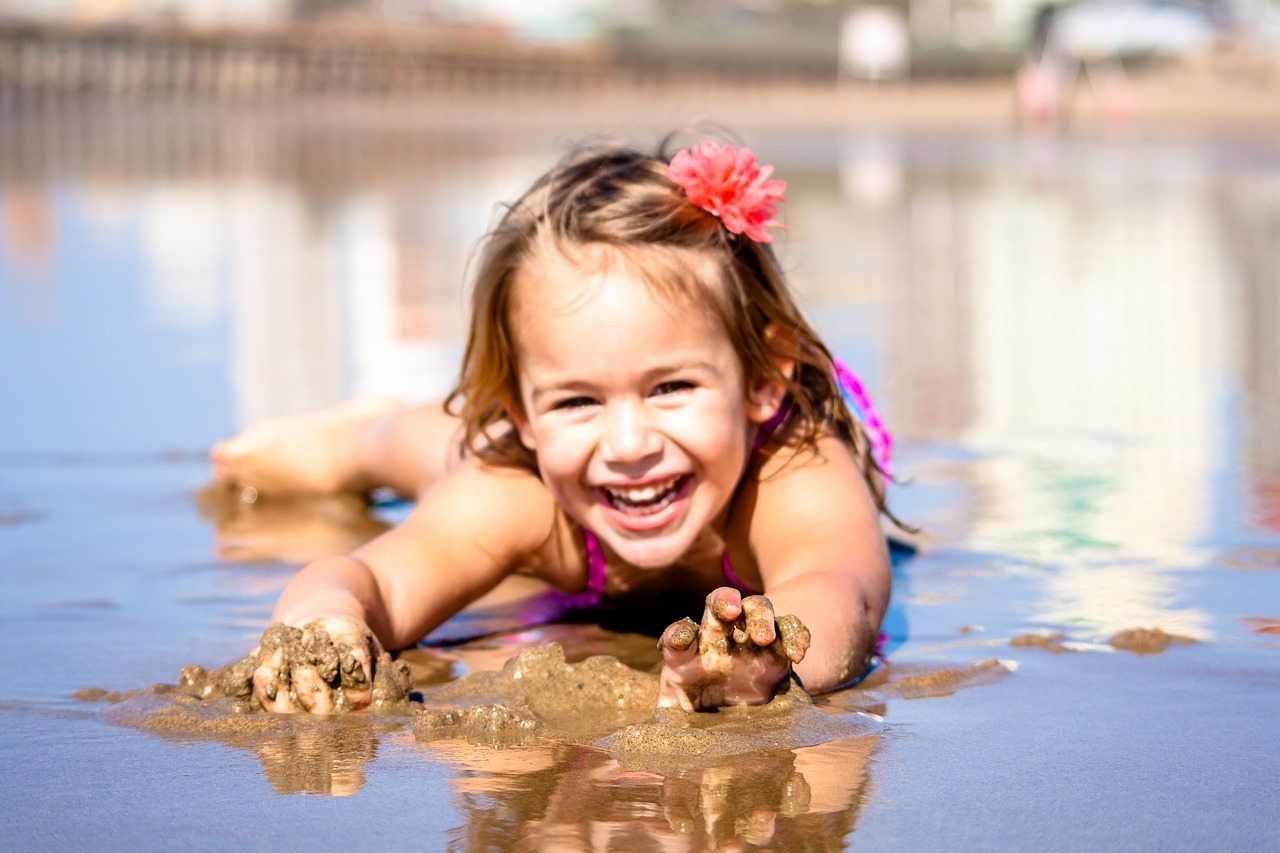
left=253, top=459, right=556, bottom=713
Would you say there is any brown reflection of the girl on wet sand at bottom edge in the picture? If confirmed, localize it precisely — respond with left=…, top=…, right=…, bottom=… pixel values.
left=409, top=735, right=879, bottom=850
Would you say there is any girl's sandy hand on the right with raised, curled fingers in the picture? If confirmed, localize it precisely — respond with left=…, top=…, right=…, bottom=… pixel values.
left=658, top=587, right=809, bottom=711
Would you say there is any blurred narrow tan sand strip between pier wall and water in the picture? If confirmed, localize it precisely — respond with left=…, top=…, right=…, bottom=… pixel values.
left=0, top=70, right=1280, bottom=140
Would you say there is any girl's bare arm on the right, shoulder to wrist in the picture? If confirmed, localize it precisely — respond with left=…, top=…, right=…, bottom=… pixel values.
left=750, top=437, right=891, bottom=693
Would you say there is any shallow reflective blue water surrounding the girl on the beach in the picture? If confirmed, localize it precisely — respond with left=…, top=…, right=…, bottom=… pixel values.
left=0, top=109, right=1280, bottom=849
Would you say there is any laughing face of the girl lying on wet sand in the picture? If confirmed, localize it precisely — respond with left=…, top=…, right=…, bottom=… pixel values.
left=511, top=256, right=782, bottom=567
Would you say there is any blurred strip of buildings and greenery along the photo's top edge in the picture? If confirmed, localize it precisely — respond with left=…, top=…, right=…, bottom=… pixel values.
left=0, top=0, right=1280, bottom=81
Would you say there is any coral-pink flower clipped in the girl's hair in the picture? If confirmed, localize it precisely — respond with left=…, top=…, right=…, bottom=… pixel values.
left=666, top=140, right=787, bottom=243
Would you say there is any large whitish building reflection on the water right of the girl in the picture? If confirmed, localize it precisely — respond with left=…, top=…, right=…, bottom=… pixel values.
left=850, top=134, right=1280, bottom=638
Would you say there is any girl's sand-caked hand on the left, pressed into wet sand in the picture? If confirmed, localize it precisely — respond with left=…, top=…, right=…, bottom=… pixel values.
left=246, top=617, right=381, bottom=715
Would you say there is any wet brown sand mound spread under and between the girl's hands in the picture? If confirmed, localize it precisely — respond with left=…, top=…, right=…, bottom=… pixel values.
left=78, top=635, right=901, bottom=773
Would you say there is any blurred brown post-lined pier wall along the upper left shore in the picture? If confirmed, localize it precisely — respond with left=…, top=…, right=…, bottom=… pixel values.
left=0, top=22, right=835, bottom=102
